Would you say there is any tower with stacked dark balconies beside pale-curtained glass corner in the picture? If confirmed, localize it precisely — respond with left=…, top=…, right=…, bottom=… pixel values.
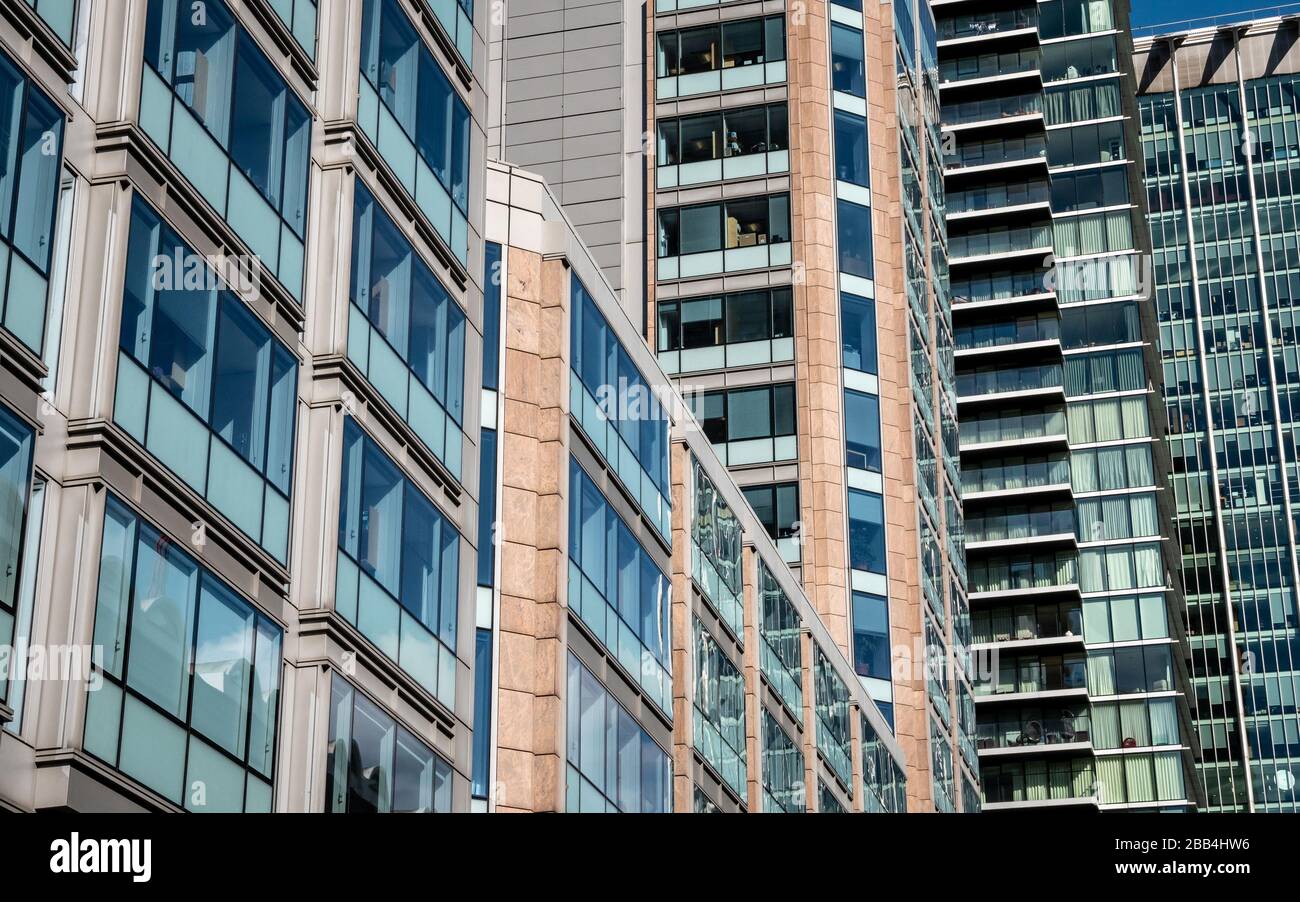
left=935, top=0, right=1197, bottom=810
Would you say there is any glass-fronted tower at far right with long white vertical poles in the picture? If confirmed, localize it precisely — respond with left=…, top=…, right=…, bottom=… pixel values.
left=1135, top=16, right=1300, bottom=812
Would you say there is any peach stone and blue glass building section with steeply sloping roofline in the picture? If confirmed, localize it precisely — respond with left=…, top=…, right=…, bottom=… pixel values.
left=475, top=164, right=906, bottom=812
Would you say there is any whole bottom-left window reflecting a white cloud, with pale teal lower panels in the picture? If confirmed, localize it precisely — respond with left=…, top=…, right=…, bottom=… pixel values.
left=85, top=496, right=283, bottom=811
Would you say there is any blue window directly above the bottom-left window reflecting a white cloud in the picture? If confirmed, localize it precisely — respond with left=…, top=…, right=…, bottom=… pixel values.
left=113, top=198, right=298, bottom=563
